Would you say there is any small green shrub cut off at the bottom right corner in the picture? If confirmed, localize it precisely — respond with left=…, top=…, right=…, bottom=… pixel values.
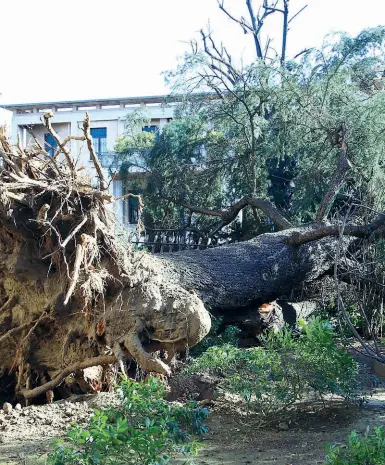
left=325, top=427, right=385, bottom=465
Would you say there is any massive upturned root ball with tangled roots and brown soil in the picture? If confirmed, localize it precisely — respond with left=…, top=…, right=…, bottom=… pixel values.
left=0, top=114, right=210, bottom=399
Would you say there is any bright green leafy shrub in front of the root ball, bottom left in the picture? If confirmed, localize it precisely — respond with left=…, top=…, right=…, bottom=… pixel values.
left=48, top=378, right=208, bottom=465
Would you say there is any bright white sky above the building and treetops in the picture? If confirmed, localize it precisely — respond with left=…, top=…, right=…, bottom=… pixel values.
left=0, top=0, right=385, bottom=105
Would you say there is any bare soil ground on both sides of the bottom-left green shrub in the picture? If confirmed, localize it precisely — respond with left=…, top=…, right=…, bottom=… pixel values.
left=0, top=389, right=385, bottom=465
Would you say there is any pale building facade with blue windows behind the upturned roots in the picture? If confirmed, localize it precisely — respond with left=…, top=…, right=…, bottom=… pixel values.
left=2, top=96, right=180, bottom=229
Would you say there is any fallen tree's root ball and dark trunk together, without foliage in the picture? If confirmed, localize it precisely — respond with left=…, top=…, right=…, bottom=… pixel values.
left=0, top=117, right=385, bottom=400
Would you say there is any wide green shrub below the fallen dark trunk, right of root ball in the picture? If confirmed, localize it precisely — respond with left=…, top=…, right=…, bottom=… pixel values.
left=186, top=319, right=359, bottom=421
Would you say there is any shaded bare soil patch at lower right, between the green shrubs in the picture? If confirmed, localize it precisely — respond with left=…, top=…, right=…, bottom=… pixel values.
left=196, top=390, right=385, bottom=465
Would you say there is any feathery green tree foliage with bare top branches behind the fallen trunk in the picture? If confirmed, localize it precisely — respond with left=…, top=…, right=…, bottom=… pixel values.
left=117, top=1, right=385, bottom=243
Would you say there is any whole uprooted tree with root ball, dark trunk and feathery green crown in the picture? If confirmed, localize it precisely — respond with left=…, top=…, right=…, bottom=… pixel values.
left=0, top=2, right=385, bottom=400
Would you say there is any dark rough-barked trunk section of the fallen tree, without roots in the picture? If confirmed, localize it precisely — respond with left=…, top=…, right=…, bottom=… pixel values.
left=161, top=226, right=351, bottom=311
